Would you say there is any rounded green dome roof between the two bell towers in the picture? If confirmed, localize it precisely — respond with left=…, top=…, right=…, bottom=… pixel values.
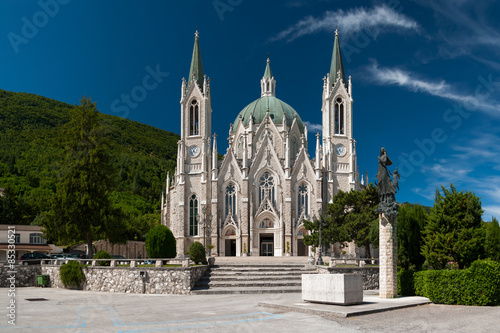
left=233, top=96, right=304, bottom=133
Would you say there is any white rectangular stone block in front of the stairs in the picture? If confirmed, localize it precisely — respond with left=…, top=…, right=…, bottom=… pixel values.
left=302, top=274, right=363, bottom=305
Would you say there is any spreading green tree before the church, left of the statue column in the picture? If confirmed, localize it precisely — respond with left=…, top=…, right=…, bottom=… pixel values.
left=304, top=184, right=379, bottom=257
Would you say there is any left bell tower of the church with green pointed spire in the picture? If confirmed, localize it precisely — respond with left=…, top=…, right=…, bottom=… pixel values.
left=170, top=30, right=213, bottom=254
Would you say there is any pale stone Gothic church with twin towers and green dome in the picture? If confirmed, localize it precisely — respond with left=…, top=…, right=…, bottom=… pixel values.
left=161, top=32, right=361, bottom=256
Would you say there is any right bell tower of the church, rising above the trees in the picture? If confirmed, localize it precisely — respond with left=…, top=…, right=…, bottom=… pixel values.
left=322, top=30, right=359, bottom=202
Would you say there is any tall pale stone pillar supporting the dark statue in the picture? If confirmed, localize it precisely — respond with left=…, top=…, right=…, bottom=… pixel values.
left=379, top=213, right=398, bottom=298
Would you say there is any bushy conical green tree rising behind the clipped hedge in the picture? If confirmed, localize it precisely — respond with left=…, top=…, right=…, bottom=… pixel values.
left=422, top=184, right=484, bottom=269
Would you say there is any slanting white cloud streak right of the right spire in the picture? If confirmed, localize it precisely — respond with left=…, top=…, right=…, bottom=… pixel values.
left=368, top=61, right=500, bottom=116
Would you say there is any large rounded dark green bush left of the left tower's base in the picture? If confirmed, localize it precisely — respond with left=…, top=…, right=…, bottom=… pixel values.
left=146, top=224, right=177, bottom=258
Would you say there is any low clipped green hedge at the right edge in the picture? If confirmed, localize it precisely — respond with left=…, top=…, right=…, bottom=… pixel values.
left=414, top=259, right=500, bottom=305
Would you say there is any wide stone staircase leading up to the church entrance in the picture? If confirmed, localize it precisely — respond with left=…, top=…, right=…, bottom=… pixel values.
left=191, top=263, right=316, bottom=295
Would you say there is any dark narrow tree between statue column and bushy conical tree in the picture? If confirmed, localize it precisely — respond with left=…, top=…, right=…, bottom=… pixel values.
left=397, top=203, right=427, bottom=270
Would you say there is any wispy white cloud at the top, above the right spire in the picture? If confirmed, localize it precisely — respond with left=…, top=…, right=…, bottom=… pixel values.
left=269, top=5, right=419, bottom=42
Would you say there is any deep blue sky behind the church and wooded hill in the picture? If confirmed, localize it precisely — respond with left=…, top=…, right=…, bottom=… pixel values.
left=0, top=0, right=500, bottom=220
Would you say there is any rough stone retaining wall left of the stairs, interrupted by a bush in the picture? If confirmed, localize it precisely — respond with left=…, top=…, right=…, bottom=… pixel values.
left=42, top=265, right=208, bottom=295
